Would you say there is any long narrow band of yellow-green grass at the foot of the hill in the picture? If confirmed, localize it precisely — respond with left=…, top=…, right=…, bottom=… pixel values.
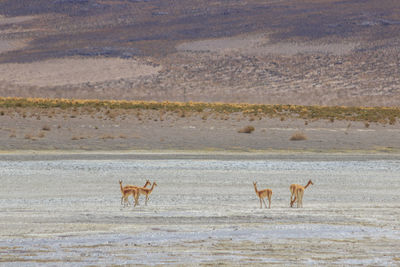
left=0, top=97, right=400, bottom=124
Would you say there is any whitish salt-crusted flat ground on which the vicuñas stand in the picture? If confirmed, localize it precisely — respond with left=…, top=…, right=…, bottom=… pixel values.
left=0, top=152, right=400, bottom=266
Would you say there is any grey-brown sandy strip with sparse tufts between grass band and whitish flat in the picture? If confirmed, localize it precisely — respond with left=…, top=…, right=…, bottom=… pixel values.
left=0, top=109, right=400, bottom=153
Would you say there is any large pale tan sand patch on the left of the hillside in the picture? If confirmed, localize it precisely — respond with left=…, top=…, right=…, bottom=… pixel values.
left=0, top=58, right=161, bottom=86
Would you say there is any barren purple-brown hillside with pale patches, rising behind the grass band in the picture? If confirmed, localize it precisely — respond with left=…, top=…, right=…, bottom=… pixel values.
left=0, top=0, right=400, bottom=106
